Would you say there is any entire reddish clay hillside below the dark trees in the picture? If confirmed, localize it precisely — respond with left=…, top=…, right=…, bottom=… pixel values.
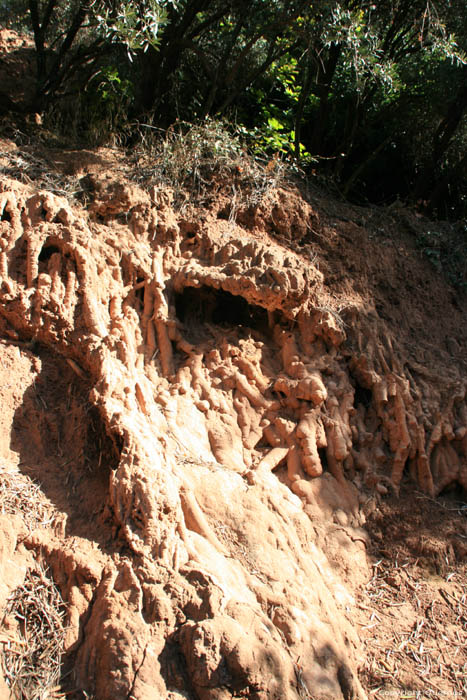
left=0, top=24, right=467, bottom=700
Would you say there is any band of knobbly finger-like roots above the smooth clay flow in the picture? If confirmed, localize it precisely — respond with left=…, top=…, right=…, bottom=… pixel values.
left=0, top=182, right=466, bottom=504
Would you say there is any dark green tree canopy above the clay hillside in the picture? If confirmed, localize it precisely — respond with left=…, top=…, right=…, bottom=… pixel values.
left=0, top=0, right=467, bottom=217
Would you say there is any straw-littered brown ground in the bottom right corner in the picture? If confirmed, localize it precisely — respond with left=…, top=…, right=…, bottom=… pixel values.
left=357, top=494, right=467, bottom=700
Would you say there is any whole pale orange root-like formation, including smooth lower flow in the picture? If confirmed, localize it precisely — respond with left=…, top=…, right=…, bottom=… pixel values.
left=0, top=183, right=467, bottom=700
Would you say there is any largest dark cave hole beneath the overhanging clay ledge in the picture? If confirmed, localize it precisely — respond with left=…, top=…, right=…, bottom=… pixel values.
left=175, top=286, right=268, bottom=332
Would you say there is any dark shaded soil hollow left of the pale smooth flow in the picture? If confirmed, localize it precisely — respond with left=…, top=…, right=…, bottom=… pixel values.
left=11, top=347, right=118, bottom=550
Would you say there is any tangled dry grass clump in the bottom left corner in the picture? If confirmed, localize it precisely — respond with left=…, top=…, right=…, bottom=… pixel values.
left=1, top=565, right=65, bottom=700
